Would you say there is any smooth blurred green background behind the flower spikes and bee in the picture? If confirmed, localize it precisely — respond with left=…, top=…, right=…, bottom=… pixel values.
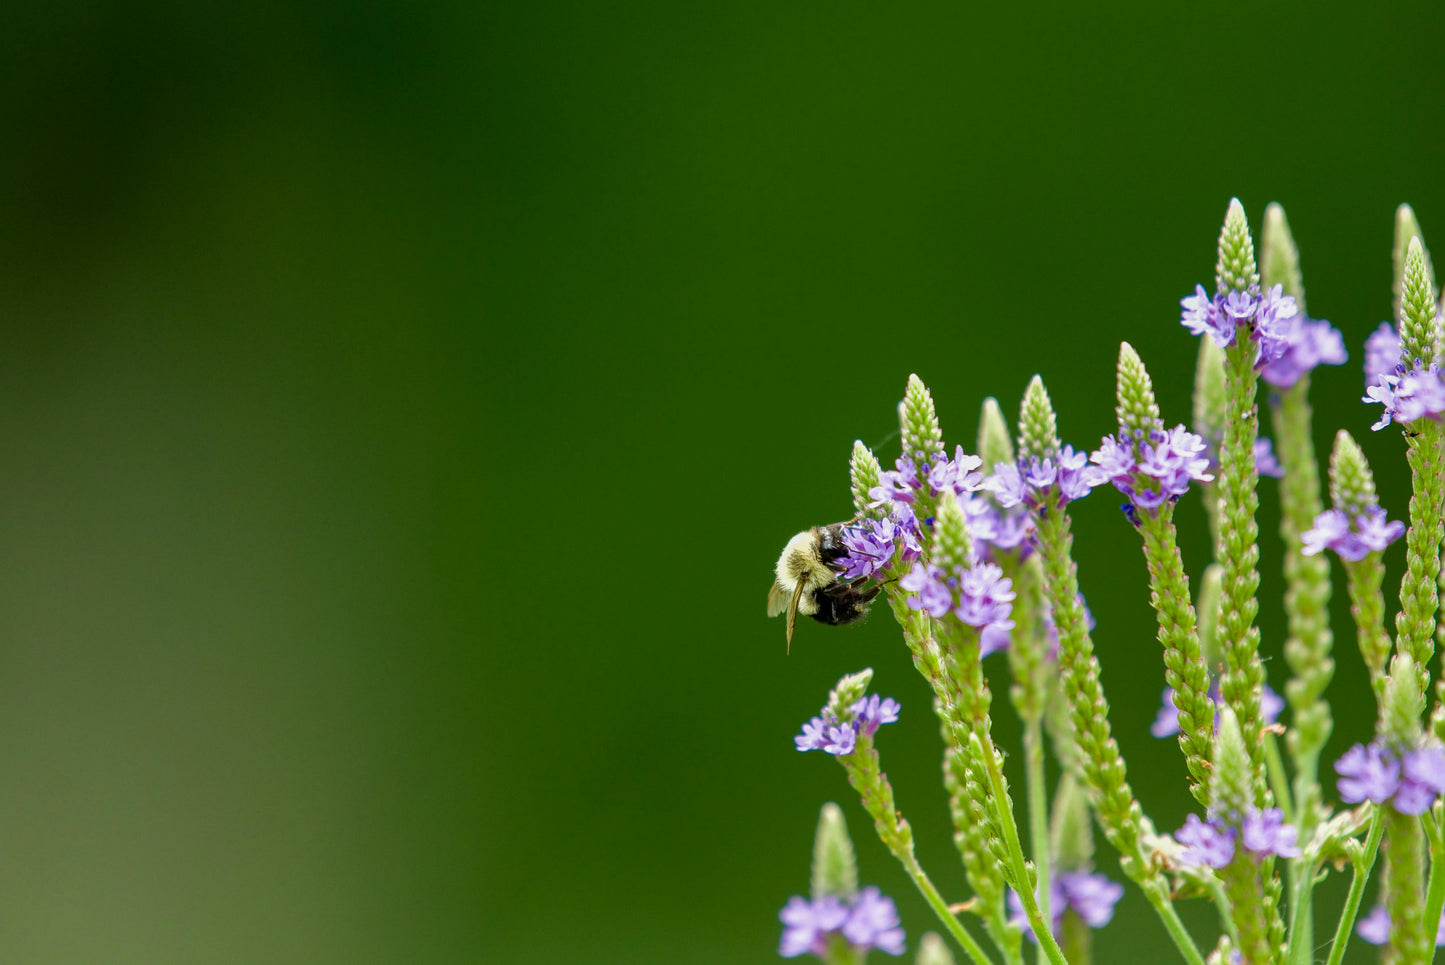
left=0, top=0, right=1445, bottom=965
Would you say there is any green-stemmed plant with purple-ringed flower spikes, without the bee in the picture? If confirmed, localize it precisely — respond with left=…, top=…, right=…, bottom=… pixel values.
left=779, top=201, right=1445, bottom=965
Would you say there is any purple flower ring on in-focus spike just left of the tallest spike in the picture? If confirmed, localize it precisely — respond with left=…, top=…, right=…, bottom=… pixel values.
left=1090, top=426, right=1214, bottom=513
